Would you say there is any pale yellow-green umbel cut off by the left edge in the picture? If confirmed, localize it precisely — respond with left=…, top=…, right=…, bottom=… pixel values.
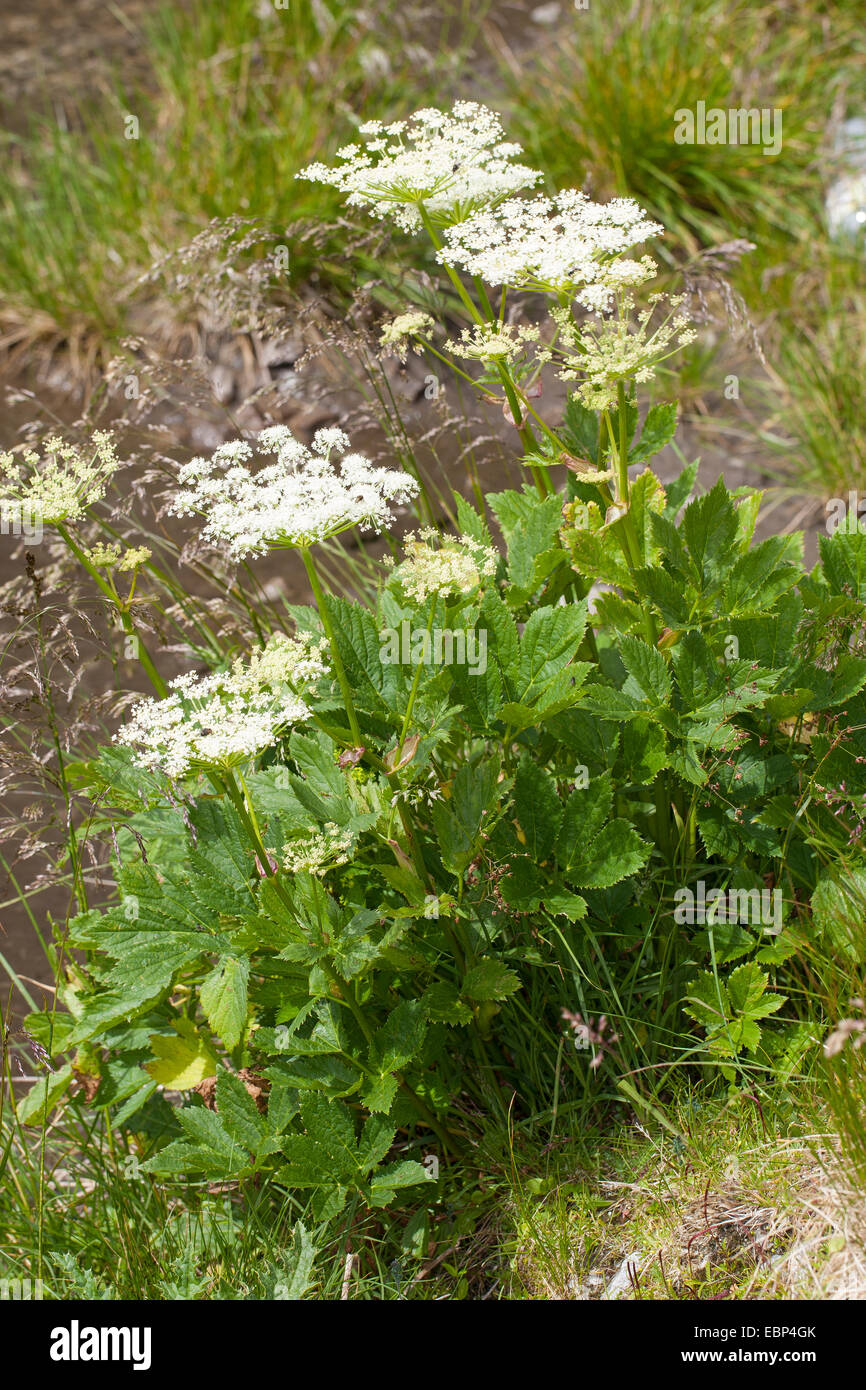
left=0, top=430, right=120, bottom=525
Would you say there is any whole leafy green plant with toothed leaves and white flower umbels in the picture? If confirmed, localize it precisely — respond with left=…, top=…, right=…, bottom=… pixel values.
left=18, top=103, right=866, bottom=1218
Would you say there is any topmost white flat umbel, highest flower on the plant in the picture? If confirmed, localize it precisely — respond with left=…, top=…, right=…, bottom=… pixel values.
left=297, top=101, right=541, bottom=231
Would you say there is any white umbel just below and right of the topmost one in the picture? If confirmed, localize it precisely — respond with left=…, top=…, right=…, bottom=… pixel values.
left=438, top=189, right=663, bottom=309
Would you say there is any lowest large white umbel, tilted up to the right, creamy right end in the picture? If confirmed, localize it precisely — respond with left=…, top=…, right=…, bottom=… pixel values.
left=115, top=632, right=325, bottom=777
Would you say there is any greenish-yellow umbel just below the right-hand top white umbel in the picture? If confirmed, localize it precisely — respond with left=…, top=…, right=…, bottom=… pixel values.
left=538, top=295, right=696, bottom=410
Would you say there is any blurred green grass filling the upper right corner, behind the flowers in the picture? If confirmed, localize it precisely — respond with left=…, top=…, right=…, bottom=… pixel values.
left=503, top=0, right=863, bottom=511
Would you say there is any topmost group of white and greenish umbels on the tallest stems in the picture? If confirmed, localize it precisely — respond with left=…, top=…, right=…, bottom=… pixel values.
left=303, top=101, right=695, bottom=408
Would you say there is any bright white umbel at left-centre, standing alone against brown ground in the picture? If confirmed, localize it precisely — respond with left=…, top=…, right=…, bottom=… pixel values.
left=171, top=425, right=418, bottom=559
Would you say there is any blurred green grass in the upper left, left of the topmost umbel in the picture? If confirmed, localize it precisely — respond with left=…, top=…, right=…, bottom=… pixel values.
left=0, top=0, right=483, bottom=342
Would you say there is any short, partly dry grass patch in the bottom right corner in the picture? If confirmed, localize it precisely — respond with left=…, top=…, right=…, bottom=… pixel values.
left=509, top=1101, right=866, bottom=1301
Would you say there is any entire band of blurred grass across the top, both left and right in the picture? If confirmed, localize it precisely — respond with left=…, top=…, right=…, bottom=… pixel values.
left=0, top=0, right=866, bottom=496
